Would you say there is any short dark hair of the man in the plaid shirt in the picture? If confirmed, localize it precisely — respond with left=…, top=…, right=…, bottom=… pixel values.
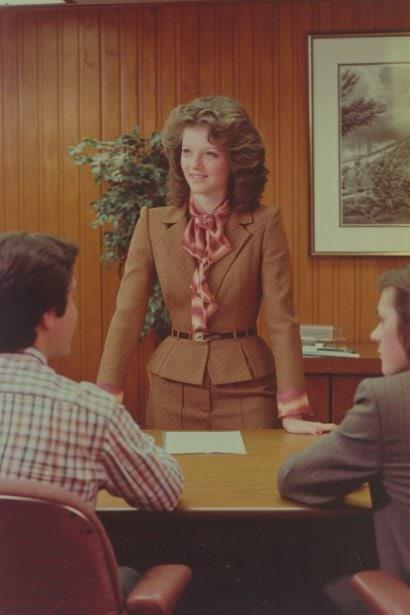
left=0, top=232, right=78, bottom=352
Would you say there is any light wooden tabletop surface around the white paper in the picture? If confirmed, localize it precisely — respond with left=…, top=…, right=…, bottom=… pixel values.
left=97, top=429, right=371, bottom=517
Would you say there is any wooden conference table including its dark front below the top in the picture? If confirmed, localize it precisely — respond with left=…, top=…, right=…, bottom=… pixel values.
left=97, top=430, right=374, bottom=615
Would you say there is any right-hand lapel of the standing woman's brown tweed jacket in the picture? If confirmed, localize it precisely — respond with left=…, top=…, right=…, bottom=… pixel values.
left=209, top=209, right=253, bottom=296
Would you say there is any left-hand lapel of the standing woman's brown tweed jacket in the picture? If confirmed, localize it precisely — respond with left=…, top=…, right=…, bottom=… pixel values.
left=162, top=207, right=196, bottom=285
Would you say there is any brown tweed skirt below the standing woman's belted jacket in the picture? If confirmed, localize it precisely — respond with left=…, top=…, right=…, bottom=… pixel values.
left=146, top=374, right=277, bottom=430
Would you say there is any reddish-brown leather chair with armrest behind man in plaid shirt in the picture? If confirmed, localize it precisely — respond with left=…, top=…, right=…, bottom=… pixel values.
left=0, top=479, right=192, bottom=615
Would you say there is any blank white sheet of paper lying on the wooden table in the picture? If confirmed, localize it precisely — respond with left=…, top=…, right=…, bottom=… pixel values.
left=165, top=431, right=246, bottom=455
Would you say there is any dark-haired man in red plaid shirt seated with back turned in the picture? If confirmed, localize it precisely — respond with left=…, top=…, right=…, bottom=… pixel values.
left=0, top=233, right=183, bottom=592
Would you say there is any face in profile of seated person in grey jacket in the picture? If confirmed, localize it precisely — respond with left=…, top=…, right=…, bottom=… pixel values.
left=370, top=286, right=410, bottom=376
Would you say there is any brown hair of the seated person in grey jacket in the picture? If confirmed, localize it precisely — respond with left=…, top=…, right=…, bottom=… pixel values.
left=379, top=265, right=410, bottom=358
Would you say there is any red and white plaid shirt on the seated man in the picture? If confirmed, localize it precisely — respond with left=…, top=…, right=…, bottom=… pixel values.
left=0, top=348, right=183, bottom=510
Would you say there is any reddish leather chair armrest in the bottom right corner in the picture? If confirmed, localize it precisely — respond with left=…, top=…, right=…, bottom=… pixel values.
left=351, top=570, right=410, bottom=615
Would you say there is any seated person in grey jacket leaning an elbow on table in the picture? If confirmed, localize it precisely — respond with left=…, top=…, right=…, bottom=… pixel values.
left=278, top=265, right=410, bottom=614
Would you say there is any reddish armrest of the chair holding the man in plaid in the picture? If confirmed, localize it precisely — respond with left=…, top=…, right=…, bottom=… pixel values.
left=125, top=564, right=192, bottom=615
